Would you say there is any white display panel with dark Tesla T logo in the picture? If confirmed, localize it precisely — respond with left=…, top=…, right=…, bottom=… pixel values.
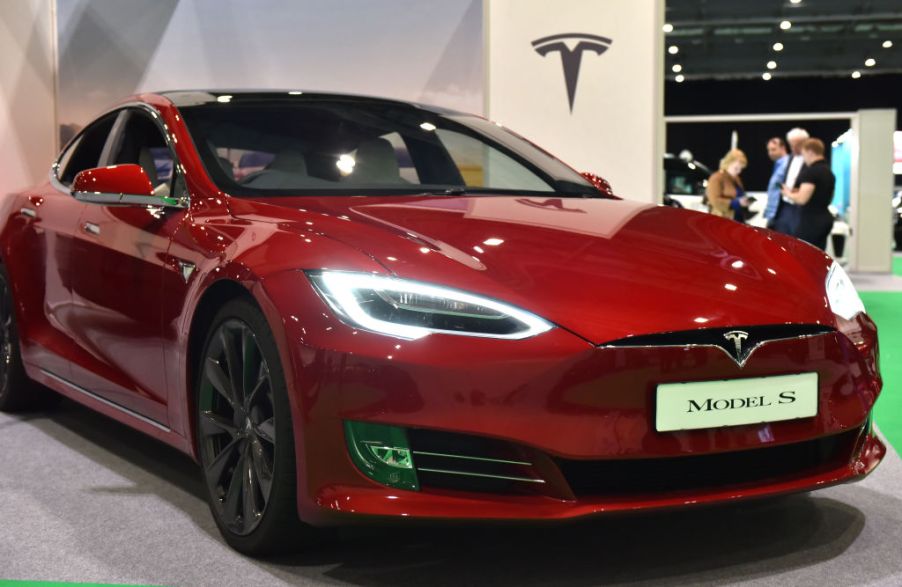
left=484, top=0, right=664, bottom=202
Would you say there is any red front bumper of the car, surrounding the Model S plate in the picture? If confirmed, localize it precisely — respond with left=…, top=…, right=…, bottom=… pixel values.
left=260, top=276, right=885, bottom=525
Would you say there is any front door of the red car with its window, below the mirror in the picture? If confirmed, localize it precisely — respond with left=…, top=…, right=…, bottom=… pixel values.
left=72, top=107, right=185, bottom=426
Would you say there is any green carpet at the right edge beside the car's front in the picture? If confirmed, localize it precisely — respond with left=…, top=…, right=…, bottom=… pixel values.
left=861, top=292, right=902, bottom=451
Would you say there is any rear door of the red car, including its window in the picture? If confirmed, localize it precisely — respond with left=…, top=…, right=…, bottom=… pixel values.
left=5, top=114, right=116, bottom=381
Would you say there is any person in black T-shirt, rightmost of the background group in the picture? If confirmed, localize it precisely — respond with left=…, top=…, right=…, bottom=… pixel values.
left=783, top=139, right=836, bottom=250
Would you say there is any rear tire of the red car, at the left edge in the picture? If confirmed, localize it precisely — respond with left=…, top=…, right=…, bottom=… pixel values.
left=0, top=265, right=59, bottom=412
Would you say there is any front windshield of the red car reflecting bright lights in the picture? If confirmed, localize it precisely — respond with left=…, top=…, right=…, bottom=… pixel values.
left=180, top=96, right=599, bottom=196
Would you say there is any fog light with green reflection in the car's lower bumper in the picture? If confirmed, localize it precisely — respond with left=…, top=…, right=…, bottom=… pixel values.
left=345, top=421, right=420, bottom=491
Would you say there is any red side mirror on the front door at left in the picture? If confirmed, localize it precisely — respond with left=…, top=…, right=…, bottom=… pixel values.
left=72, top=163, right=183, bottom=207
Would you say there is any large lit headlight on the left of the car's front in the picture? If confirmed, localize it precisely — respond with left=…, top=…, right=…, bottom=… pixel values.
left=307, top=271, right=553, bottom=339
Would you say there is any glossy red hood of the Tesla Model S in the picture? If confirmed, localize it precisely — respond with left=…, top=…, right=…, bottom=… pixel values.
left=233, top=196, right=834, bottom=344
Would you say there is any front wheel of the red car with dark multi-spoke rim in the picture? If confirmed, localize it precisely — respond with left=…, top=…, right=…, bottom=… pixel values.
left=195, top=298, right=313, bottom=556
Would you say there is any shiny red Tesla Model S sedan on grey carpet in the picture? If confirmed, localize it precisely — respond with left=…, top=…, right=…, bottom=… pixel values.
left=0, top=91, right=885, bottom=553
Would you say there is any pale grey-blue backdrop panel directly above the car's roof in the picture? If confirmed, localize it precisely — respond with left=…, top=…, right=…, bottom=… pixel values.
left=57, top=0, right=483, bottom=140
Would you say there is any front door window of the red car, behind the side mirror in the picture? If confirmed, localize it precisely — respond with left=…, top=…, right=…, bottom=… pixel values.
left=109, top=109, right=174, bottom=197
